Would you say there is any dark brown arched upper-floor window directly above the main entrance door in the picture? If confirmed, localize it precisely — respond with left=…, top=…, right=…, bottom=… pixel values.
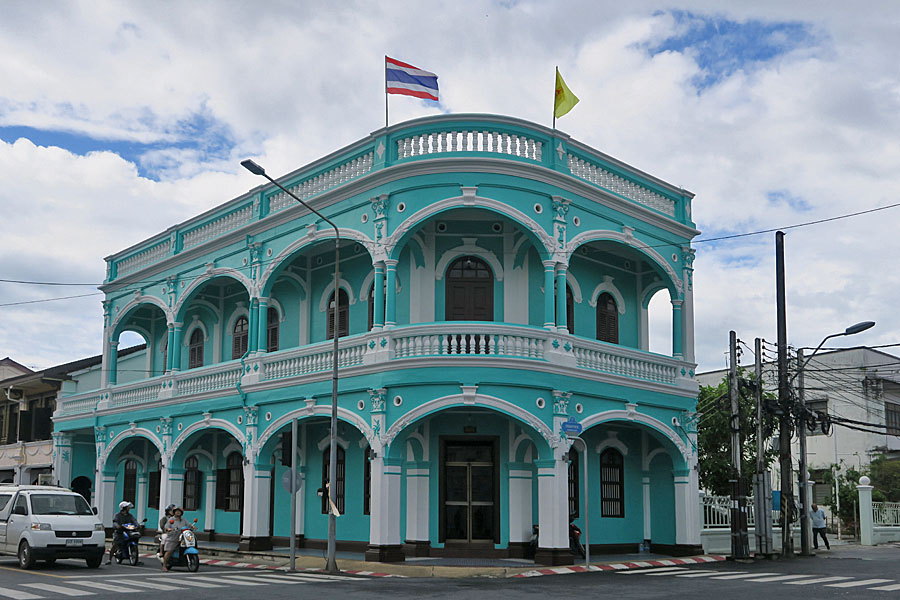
left=444, top=256, right=494, bottom=321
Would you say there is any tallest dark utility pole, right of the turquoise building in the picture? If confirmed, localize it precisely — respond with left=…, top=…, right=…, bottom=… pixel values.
left=775, top=231, right=794, bottom=558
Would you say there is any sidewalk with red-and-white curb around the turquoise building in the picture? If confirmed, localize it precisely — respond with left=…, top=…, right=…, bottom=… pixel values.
left=132, top=542, right=724, bottom=578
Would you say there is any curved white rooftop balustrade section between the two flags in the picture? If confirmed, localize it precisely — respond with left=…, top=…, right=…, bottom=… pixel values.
left=397, top=129, right=543, bottom=162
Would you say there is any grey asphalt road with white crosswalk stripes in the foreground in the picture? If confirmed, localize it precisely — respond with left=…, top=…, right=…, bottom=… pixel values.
left=0, top=545, right=900, bottom=600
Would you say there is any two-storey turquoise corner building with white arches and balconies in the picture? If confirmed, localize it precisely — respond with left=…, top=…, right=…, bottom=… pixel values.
left=54, top=115, right=699, bottom=563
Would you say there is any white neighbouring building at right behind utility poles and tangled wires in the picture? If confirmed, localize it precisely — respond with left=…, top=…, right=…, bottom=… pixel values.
left=697, top=348, right=900, bottom=504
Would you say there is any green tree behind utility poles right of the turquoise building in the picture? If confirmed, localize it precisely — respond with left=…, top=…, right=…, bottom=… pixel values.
left=697, top=370, right=775, bottom=496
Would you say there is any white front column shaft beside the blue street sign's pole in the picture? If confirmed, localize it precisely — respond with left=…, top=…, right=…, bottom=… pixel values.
left=537, top=458, right=569, bottom=550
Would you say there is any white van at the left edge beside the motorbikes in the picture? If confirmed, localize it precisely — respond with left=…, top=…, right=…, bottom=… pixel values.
left=0, top=484, right=106, bottom=569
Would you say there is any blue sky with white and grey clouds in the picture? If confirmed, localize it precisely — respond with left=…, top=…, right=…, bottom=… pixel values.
left=0, top=0, right=900, bottom=371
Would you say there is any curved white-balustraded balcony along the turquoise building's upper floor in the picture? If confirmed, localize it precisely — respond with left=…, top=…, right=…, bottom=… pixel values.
left=54, top=321, right=697, bottom=419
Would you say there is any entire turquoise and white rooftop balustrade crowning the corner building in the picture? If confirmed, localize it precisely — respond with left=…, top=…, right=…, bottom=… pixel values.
left=106, top=115, right=692, bottom=283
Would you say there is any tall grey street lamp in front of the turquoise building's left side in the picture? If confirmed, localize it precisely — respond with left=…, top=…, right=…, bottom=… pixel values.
left=241, top=158, right=341, bottom=573
